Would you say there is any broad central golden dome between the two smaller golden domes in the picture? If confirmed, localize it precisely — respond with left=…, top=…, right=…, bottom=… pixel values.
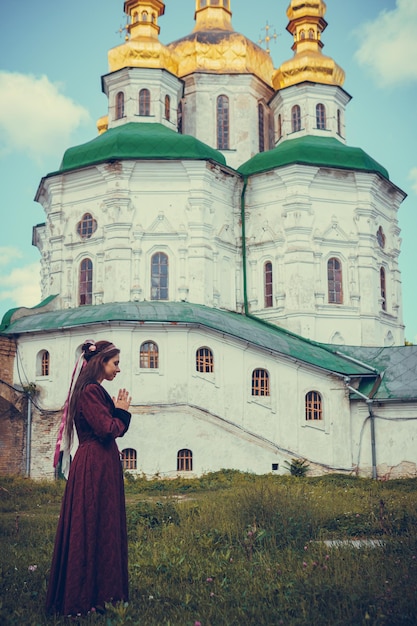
left=169, top=0, right=274, bottom=85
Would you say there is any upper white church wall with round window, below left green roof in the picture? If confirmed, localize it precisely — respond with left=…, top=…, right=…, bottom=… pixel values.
left=37, top=161, right=240, bottom=309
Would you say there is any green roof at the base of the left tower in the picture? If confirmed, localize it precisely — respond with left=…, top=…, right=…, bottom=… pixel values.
left=59, top=122, right=226, bottom=172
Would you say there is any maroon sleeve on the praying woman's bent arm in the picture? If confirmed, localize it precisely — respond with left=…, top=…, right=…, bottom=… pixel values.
left=79, top=384, right=131, bottom=439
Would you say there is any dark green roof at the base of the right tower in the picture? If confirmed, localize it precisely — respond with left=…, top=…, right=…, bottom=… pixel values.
left=238, top=135, right=389, bottom=180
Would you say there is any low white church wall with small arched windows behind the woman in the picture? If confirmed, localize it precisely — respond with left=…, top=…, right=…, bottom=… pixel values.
left=20, top=322, right=349, bottom=477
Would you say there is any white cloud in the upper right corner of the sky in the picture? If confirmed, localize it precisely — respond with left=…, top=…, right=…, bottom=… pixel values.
left=355, top=0, right=417, bottom=87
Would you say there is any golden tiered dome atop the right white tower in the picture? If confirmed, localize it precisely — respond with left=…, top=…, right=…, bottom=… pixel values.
left=272, top=0, right=345, bottom=90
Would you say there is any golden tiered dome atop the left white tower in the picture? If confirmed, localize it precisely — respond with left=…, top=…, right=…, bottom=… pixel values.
left=108, top=0, right=178, bottom=74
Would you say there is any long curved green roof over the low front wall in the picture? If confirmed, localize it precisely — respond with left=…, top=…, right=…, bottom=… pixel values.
left=2, top=301, right=376, bottom=378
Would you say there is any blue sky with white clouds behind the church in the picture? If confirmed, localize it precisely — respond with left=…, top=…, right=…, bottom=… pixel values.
left=0, top=0, right=417, bottom=343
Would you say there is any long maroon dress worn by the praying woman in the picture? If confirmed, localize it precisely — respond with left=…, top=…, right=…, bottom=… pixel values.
left=46, top=383, right=130, bottom=615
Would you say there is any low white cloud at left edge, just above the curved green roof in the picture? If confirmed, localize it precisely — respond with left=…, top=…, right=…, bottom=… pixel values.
left=0, top=260, right=41, bottom=307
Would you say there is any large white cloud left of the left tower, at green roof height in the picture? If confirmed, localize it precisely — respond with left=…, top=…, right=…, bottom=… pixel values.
left=0, top=71, right=90, bottom=161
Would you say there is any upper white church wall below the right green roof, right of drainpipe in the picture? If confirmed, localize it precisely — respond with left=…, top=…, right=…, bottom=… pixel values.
left=240, top=165, right=403, bottom=345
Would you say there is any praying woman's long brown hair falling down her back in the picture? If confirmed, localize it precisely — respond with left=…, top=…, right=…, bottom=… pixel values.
left=65, top=341, right=120, bottom=441
